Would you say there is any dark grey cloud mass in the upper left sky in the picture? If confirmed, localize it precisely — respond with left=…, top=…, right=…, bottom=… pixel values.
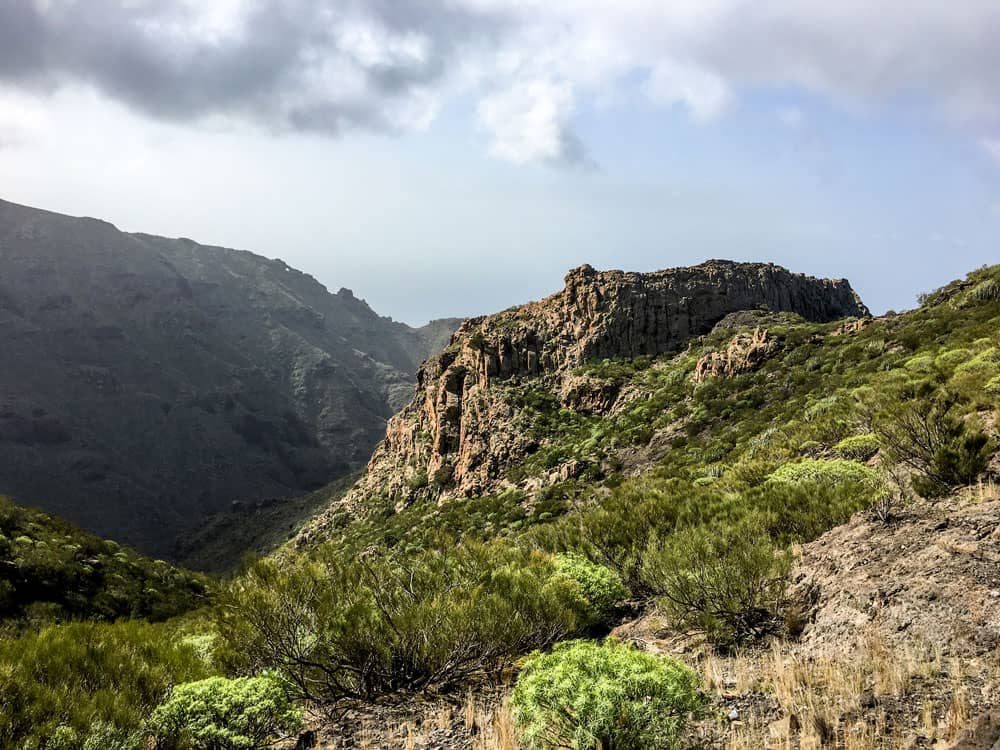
left=0, top=0, right=504, bottom=133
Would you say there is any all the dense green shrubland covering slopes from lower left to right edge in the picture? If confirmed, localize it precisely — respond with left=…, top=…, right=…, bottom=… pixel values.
left=0, top=268, right=1000, bottom=748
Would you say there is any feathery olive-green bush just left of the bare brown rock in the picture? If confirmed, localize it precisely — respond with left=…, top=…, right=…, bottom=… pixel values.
left=642, top=522, right=789, bottom=649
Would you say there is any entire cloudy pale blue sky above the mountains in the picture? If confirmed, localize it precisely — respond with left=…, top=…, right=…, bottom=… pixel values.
left=0, top=0, right=1000, bottom=324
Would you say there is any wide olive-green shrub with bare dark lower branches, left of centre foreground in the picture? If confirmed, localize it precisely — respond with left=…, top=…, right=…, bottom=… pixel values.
left=219, top=542, right=588, bottom=701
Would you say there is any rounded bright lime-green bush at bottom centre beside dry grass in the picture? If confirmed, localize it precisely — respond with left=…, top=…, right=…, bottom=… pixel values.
left=510, top=641, right=702, bottom=750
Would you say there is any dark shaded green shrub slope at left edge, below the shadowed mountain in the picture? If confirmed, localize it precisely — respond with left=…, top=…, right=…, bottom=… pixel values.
left=0, top=497, right=207, bottom=630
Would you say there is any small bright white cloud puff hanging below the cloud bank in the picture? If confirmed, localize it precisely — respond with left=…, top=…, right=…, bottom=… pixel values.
left=478, top=79, right=583, bottom=164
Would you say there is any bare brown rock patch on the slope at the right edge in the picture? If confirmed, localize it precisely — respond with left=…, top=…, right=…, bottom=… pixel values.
left=792, top=498, right=1000, bottom=657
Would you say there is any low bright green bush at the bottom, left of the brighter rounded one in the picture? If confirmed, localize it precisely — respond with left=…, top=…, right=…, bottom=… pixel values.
left=150, top=674, right=302, bottom=750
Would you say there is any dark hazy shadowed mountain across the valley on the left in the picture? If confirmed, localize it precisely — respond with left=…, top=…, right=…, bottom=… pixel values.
left=0, top=201, right=458, bottom=558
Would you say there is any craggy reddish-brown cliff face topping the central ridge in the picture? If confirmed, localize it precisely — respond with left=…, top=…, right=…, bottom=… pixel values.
left=312, top=260, right=867, bottom=523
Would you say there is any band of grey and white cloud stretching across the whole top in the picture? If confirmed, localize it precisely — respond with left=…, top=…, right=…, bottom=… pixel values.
left=0, top=0, right=1000, bottom=163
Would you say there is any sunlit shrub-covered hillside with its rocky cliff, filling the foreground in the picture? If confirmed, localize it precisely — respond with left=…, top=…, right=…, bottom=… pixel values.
left=0, top=261, right=1000, bottom=750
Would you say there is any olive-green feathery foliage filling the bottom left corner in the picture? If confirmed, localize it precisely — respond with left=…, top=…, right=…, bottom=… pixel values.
left=0, top=621, right=210, bottom=750
